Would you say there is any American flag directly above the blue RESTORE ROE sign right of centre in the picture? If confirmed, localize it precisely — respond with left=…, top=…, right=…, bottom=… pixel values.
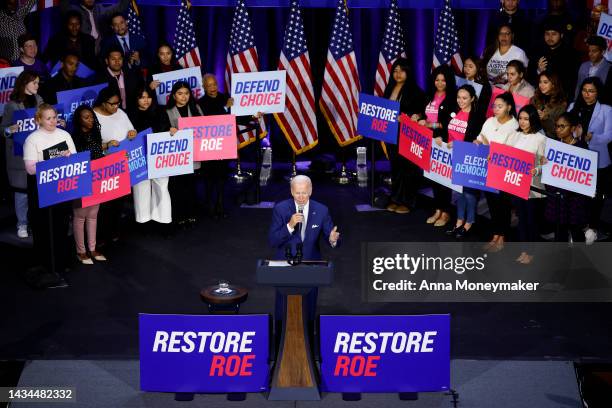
left=374, top=0, right=406, bottom=96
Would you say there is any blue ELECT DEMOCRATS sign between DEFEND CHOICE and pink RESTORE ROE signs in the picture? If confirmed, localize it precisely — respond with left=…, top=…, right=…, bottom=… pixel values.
left=452, top=141, right=498, bottom=193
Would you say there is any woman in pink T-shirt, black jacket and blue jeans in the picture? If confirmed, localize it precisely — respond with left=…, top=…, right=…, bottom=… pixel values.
left=446, top=85, right=484, bottom=239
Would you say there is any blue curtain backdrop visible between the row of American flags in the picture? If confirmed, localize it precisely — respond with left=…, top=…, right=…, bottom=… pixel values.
left=32, top=0, right=585, bottom=159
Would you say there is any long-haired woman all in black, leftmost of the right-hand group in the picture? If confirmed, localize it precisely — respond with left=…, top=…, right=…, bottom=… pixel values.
left=384, top=58, right=425, bottom=214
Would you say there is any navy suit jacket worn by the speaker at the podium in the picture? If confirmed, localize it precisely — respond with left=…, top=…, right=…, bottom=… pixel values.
left=268, top=198, right=340, bottom=260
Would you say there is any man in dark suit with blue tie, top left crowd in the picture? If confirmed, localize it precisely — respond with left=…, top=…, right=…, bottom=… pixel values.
left=100, top=13, right=148, bottom=68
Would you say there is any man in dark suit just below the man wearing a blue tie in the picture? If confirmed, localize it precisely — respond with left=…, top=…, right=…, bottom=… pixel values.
left=93, top=48, right=144, bottom=110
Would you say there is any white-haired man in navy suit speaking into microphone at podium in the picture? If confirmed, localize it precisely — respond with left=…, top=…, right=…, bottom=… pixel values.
left=268, top=175, right=340, bottom=261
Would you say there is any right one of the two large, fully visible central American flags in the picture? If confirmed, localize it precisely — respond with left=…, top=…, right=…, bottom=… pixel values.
left=319, top=0, right=361, bottom=146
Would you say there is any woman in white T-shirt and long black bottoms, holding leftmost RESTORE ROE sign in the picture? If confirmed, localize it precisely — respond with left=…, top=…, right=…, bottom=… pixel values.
left=23, top=103, right=76, bottom=273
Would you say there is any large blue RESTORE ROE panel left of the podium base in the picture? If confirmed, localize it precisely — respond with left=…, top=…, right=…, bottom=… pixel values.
left=139, top=314, right=270, bottom=392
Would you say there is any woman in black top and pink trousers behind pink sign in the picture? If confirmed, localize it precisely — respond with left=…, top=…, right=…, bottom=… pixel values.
left=72, top=105, right=106, bottom=265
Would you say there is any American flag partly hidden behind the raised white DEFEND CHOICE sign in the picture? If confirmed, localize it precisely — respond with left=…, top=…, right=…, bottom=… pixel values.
left=225, top=0, right=266, bottom=148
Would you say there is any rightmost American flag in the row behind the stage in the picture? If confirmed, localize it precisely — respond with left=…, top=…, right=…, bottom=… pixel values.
left=432, top=0, right=463, bottom=74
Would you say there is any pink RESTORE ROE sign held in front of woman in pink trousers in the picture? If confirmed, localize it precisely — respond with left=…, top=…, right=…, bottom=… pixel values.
left=82, top=150, right=132, bottom=207
